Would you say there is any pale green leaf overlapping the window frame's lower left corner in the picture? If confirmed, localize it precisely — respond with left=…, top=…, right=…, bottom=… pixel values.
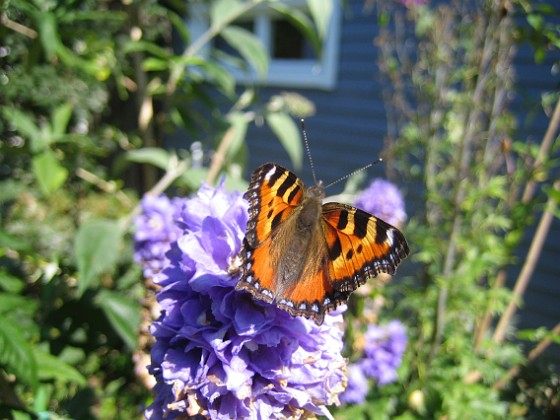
left=220, top=26, right=268, bottom=78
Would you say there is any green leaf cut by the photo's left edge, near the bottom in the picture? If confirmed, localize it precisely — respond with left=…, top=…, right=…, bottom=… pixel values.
left=0, top=317, right=37, bottom=387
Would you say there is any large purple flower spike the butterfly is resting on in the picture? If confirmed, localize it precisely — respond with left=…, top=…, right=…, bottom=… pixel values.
left=140, top=184, right=346, bottom=419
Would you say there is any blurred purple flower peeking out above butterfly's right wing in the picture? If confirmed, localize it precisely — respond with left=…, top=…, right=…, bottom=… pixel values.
left=354, top=179, right=406, bottom=227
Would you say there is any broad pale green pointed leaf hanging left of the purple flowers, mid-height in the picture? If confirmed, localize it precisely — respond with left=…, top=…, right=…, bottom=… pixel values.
left=74, top=220, right=123, bottom=295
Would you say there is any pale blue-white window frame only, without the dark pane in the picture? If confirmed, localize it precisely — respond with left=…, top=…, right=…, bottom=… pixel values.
left=187, top=0, right=341, bottom=90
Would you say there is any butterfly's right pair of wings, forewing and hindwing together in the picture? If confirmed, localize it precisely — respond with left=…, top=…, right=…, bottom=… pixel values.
left=276, top=203, right=409, bottom=325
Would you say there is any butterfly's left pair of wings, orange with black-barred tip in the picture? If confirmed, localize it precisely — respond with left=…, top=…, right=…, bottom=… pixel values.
left=235, top=163, right=305, bottom=302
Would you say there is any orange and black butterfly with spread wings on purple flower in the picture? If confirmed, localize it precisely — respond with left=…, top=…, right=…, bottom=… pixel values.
left=235, top=163, right=409, bottom=325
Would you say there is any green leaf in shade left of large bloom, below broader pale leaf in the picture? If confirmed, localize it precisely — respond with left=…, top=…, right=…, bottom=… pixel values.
left=95, top=290, right=140, bottom=349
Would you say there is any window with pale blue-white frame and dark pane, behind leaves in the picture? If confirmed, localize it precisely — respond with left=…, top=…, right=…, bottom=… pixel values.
left=189, top=0, right=341, bottom=90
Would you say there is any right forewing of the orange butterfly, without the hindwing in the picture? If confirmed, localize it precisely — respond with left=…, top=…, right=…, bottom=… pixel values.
left=323, top=203, right=409, bottom=294
